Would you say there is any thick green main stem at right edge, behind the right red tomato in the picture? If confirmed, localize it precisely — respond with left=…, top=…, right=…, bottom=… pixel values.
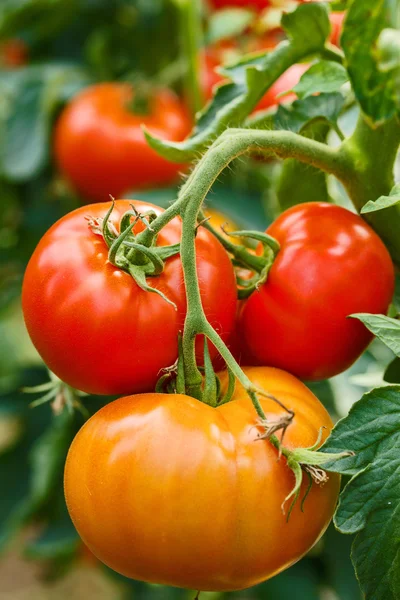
left=340, top=115, right=400, bottom=265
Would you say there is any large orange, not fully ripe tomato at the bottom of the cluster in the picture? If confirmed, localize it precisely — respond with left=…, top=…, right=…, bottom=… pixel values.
left=64, top=368, right=339, bottom=591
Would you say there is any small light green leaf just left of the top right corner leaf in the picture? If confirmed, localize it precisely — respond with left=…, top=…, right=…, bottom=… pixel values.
left=293, top=60, right=349, bottom=98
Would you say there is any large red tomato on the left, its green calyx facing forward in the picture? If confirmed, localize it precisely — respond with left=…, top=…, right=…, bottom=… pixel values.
left=22, top=200, right=237, bottom=394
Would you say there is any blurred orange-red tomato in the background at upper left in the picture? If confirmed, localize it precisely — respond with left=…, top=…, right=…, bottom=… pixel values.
left=54, top=83, right=191, bottom=201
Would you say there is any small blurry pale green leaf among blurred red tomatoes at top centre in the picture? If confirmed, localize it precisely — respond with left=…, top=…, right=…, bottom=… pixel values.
left=207, top=8, right=254, bottom=44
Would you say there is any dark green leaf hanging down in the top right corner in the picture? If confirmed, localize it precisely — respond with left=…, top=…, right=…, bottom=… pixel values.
left=341, top=0, right=400, bottom=123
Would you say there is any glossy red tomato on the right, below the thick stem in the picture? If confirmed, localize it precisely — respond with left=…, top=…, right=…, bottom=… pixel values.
left=240, top=203, right=394, bottom=380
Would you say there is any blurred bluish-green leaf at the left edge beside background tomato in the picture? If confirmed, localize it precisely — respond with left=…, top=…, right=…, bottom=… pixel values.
left=0, top=65, right=87, bottom=182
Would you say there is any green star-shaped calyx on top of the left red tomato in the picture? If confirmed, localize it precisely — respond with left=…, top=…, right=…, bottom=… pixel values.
left=89, top=201, right=180, bottom=310
